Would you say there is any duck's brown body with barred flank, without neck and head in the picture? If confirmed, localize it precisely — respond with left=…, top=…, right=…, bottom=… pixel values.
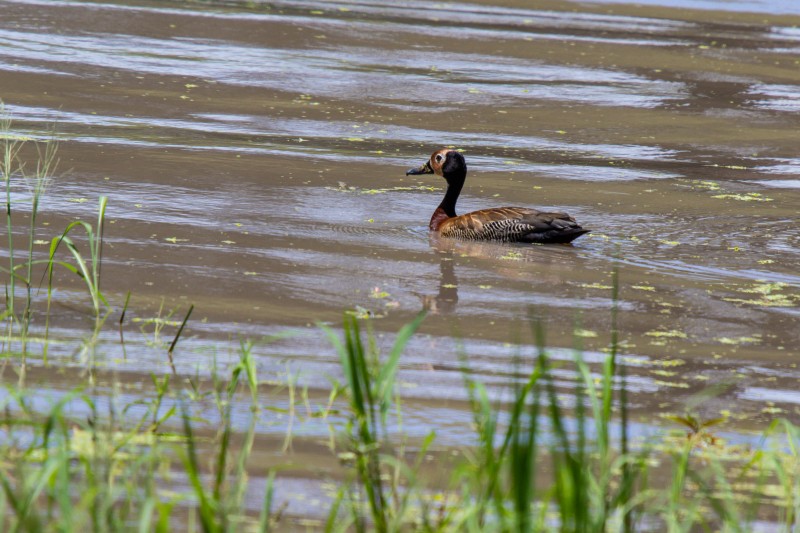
left=439, top=207, right=589, bottom=243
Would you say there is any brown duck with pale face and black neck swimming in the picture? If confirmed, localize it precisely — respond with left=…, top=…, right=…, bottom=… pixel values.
left=406, top=148, right=591, bottom=244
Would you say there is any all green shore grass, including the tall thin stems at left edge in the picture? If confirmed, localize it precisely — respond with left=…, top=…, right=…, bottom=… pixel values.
left=0, top=111, right=800, bottom=532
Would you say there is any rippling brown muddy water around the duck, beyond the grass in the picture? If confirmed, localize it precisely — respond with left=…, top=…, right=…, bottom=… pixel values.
left=0, top=0, right=800, bottom=524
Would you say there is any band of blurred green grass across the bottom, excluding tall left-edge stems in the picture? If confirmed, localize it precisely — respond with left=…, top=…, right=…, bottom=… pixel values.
left=0, top=310, right=800, bottom=532
